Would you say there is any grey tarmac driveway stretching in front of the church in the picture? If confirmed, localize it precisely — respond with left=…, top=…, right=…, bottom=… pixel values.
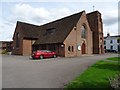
left=2, top=54, right=118, bottom=88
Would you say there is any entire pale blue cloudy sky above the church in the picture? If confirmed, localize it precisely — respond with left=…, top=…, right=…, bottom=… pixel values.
left=0, top=0, right=120, bottom=41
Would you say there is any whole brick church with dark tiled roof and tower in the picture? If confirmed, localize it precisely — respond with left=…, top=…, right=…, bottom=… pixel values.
left=12, top=11, right=104, bottom=57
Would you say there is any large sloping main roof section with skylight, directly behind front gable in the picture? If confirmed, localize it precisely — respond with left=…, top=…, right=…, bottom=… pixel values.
left=34, top=11, right=85, bottom=44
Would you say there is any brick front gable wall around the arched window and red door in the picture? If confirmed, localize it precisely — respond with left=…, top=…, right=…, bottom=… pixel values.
left=64, top=13, right=93, bottom=57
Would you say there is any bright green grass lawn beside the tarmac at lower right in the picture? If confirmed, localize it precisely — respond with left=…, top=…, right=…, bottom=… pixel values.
left=65, top=57, right=120, bottom=90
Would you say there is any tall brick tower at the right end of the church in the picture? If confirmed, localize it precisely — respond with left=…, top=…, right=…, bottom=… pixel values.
left=87, top=11, right=104, bottom=54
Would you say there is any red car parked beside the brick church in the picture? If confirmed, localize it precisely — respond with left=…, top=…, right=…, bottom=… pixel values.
left=32, top=50, right=57, bottom=59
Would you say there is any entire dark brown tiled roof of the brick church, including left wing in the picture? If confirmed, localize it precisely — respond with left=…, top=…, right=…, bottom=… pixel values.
left=13, top=11, right=85, bottom=44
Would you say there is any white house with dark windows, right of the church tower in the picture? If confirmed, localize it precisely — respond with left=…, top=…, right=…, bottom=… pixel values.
left=104, top=33, right=120, bottom=52
